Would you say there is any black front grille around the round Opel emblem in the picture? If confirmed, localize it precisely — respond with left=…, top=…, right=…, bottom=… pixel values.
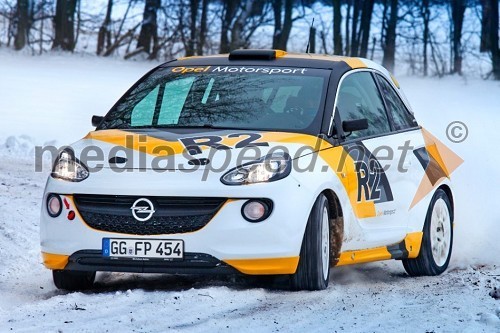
left=74, top=194, right=227, bottom=235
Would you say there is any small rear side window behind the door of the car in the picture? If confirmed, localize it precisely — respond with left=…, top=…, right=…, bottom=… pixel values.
left=377, top=74, right=416, bottom=130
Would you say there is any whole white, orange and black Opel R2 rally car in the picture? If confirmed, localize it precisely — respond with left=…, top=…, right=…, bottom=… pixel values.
left=41, top=50, right=459, bottom=290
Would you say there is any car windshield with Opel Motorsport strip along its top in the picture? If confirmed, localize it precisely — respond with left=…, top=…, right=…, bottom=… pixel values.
left=100, top=66, right=330, bottom=131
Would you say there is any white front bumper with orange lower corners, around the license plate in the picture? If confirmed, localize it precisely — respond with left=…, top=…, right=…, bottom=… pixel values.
left=41, top=167, right=316, bottom=275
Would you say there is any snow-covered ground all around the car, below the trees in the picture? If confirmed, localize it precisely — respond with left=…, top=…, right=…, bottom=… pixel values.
left=0, top=52, right=500, bottom=332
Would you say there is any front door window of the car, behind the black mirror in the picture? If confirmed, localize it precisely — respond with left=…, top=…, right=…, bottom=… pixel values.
left=336, top=72, right=391, bottom=139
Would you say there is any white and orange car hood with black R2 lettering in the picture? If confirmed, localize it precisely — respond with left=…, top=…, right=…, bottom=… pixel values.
left=71, top=129, right=332, bottom=171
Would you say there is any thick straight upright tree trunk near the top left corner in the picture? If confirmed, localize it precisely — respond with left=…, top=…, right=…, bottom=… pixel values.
left=52, top=0, right=77, bottom=52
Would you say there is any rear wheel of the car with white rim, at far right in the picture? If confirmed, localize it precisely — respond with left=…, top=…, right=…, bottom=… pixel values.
left=403, top=189, right=453, bottom=276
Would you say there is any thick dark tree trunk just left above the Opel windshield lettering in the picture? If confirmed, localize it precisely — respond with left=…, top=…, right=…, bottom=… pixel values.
left=137, top=0, right=161, bottom=59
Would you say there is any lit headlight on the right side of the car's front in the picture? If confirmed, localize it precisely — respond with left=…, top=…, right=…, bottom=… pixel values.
left=220, top=152, right=292, bottom=185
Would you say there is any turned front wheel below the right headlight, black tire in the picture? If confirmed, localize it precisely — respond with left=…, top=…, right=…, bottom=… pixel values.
left=290, top=194, right=331, bottom=290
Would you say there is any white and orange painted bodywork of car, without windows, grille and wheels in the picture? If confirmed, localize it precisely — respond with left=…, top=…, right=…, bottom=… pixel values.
left=41, top=50, right=456, bottom=288
